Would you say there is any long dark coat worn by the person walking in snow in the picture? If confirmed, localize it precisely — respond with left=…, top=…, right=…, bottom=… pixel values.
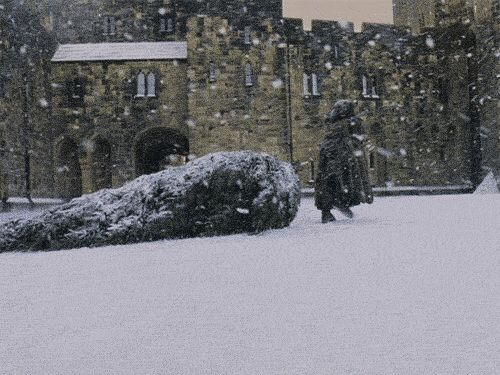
left=315, top=118, right=373, bottom=211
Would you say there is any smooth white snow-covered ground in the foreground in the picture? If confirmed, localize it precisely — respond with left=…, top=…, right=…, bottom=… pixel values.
left=0, top=195, right=500, bottom=375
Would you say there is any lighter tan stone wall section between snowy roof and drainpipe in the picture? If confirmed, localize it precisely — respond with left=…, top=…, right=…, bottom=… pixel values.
left=188, top=17, right=289, bottom=167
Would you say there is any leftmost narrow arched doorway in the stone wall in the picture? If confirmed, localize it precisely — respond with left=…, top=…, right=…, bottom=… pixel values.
left=56, top=138, right=82, bottom=199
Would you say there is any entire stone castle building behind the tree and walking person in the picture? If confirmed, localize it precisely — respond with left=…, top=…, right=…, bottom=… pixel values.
left=0, top=0, right=499, bottom=198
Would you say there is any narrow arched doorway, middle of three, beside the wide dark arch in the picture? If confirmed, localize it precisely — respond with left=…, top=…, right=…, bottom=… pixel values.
left=90, top=138, right=113, bottom=191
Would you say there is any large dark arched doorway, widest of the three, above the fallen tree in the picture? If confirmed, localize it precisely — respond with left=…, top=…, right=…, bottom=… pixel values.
left=135, top=128, right=189, bottom=176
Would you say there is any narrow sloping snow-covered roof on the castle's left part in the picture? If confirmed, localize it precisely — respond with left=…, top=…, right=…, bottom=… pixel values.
left=52, top=42, right=187, bottom=62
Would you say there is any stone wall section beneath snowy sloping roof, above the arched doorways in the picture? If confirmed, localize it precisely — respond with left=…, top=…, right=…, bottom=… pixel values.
left=52, top=61, right=189, bottom=194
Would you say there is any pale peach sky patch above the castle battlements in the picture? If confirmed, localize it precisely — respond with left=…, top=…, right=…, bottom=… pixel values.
left=283, top=0, right=392, bottom=30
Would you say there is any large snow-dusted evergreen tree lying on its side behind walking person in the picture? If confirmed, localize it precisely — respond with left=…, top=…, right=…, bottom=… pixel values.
left=0, top=151, right=300, bottom=252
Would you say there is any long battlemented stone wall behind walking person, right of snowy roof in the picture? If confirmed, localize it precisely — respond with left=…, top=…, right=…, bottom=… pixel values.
left=188, top=17, right=471, bottom=186
